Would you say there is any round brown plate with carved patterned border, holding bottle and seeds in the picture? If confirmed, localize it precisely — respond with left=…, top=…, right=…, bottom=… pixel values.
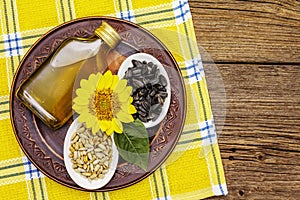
left=10, top=17, right=186, bottom=191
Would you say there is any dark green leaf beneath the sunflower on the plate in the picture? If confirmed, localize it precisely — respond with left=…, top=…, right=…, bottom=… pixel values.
left=114, top=119, right=149, bottom=171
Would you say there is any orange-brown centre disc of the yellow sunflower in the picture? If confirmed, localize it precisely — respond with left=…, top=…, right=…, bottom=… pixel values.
left=93, top=89, right=113, bottom=121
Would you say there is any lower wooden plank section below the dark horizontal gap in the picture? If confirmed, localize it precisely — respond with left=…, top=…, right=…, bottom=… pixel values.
left=205, top=64, right=300, bottom=199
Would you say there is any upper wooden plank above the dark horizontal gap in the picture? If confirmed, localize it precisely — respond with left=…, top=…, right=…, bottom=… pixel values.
left=189, top=0, right=300, bottom=63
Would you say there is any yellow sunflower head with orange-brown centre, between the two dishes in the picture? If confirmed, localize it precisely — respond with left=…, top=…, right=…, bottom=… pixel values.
left=73, top=70, right=136, bottom=135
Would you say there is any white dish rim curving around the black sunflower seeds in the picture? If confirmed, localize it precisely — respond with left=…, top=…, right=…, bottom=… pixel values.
left=118, top=53, right=171, bottom=128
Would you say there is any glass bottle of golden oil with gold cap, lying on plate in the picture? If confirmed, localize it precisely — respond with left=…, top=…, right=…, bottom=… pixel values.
left=17, top=22, right=123, bottom=129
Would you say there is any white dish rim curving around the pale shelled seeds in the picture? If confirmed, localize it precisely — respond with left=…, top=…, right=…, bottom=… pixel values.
left=64, top=119, right=119, bottom=190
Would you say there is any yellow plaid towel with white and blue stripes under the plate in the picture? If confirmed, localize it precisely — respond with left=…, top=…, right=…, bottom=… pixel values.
left=0, top=0, right=227, bottom=200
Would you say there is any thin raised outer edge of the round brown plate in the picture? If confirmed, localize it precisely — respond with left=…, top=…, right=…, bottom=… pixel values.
left=10, top=16, right=187, bottom=192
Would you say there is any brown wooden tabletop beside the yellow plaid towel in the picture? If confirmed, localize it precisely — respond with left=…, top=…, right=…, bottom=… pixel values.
left=189, top=0, right=300, bottom=200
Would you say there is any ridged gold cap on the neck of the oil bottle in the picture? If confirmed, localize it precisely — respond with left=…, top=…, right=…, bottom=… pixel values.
left=95, top=22, right=121, bottom=49
